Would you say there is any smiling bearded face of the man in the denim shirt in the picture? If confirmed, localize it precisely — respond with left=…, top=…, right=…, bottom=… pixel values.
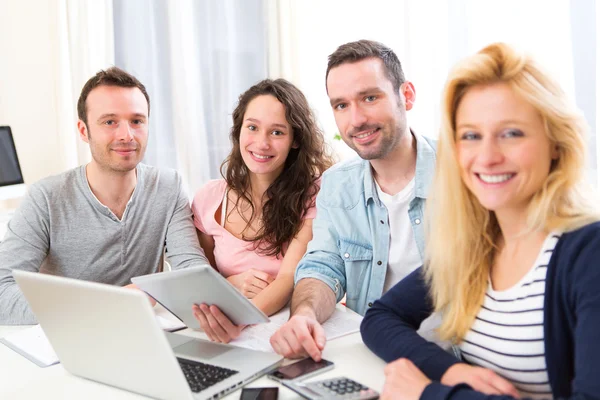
left=327, top=57, right=415, bottom=160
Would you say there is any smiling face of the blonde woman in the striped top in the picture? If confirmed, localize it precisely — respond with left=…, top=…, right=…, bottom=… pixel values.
left=455, top=83, right=558, bottom=216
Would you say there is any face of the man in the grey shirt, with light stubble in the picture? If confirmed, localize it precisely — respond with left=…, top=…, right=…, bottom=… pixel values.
left=77, top=85, right=148, bottom=173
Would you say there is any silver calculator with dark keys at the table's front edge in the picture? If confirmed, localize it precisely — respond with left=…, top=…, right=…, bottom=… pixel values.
left=281, top=377, right=379, bottom=400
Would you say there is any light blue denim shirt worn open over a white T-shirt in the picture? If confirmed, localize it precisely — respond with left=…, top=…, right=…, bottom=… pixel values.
left=294, top=132, right=436, bottom=315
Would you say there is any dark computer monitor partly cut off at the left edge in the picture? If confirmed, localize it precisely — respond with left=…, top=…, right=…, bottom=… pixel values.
left=0, top=126, right=26, bottom=200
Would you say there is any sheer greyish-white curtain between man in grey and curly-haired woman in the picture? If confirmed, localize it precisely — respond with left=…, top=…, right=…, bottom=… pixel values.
left=114, top=0, right=267, bottom=195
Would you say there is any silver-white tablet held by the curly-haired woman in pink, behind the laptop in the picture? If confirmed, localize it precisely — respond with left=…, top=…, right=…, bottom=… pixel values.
left=131, top=265, right=269, bottom=329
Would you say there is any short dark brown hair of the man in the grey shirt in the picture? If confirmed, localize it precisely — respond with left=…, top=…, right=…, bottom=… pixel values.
left=77, top=67, right=150, bottom=125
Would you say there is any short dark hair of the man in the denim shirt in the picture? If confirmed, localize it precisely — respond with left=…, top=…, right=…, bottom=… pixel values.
left=325, top=40, right=406, bottom=92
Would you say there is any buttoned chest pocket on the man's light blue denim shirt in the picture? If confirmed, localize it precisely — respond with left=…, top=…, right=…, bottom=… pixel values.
left=339, top=239, right=373, bottom=300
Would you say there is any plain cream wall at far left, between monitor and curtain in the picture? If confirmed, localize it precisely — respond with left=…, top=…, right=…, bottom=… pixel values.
left=0, top=0, right=68, bottom=183
